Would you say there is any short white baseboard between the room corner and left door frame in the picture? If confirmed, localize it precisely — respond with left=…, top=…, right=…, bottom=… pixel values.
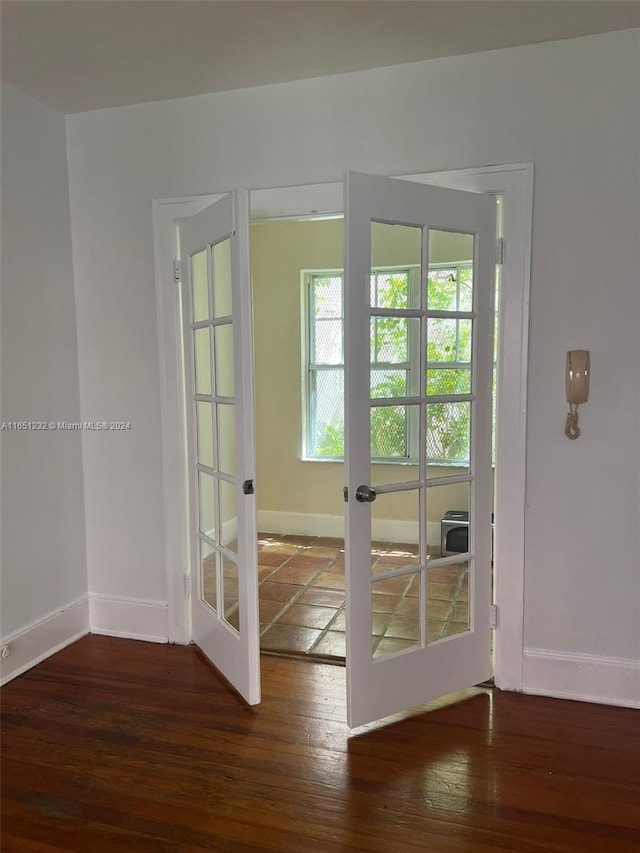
left=89, top=592, right=169, bottom=643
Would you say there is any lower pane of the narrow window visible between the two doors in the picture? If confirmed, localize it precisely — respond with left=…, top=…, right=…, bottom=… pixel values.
left=309, top=370, right=344, bottom=457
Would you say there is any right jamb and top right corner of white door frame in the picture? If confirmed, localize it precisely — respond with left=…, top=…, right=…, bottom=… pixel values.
left=404, top=163, right=533, bottom=690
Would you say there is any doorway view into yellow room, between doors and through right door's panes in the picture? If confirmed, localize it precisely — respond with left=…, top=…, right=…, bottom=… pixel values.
left=251, top=216, right=490, bottom=664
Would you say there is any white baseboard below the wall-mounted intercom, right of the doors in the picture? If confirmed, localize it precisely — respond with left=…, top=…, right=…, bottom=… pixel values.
left=522, top=649, right=640, bottom=708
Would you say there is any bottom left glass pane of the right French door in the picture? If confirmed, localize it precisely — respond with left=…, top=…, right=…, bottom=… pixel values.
left=371, top=572, right=421, bottom=659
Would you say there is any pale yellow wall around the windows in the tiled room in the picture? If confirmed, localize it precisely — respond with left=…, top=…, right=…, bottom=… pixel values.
left=251, top=220, right=476, bottom=532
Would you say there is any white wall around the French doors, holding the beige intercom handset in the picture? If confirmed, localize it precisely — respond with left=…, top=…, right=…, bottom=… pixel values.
left=67, top=31, right=640, bottom=701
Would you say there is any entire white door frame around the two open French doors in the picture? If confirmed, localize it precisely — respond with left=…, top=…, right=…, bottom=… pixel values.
left=153, top=163, right=533, bottom=690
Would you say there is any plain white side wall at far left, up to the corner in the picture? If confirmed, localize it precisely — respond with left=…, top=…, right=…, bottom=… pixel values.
left=0, top=81, right=87, bottom=674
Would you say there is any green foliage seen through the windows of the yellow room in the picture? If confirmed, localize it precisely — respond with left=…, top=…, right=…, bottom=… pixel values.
left=310, top=264, right=472, bottom=464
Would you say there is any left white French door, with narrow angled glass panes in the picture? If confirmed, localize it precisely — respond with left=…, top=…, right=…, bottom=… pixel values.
left=180, top=191, right=260, bottom=705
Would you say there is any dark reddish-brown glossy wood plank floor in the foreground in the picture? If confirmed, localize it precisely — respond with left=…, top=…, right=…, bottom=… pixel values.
left=2, top=636, right=640, bottom=853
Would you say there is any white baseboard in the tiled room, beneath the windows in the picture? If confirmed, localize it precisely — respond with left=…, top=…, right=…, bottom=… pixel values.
left=258, top=509, right=440, bottom=547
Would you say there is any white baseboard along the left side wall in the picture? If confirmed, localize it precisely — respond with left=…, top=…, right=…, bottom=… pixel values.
left=0, top=595, right=89, bottom=684
